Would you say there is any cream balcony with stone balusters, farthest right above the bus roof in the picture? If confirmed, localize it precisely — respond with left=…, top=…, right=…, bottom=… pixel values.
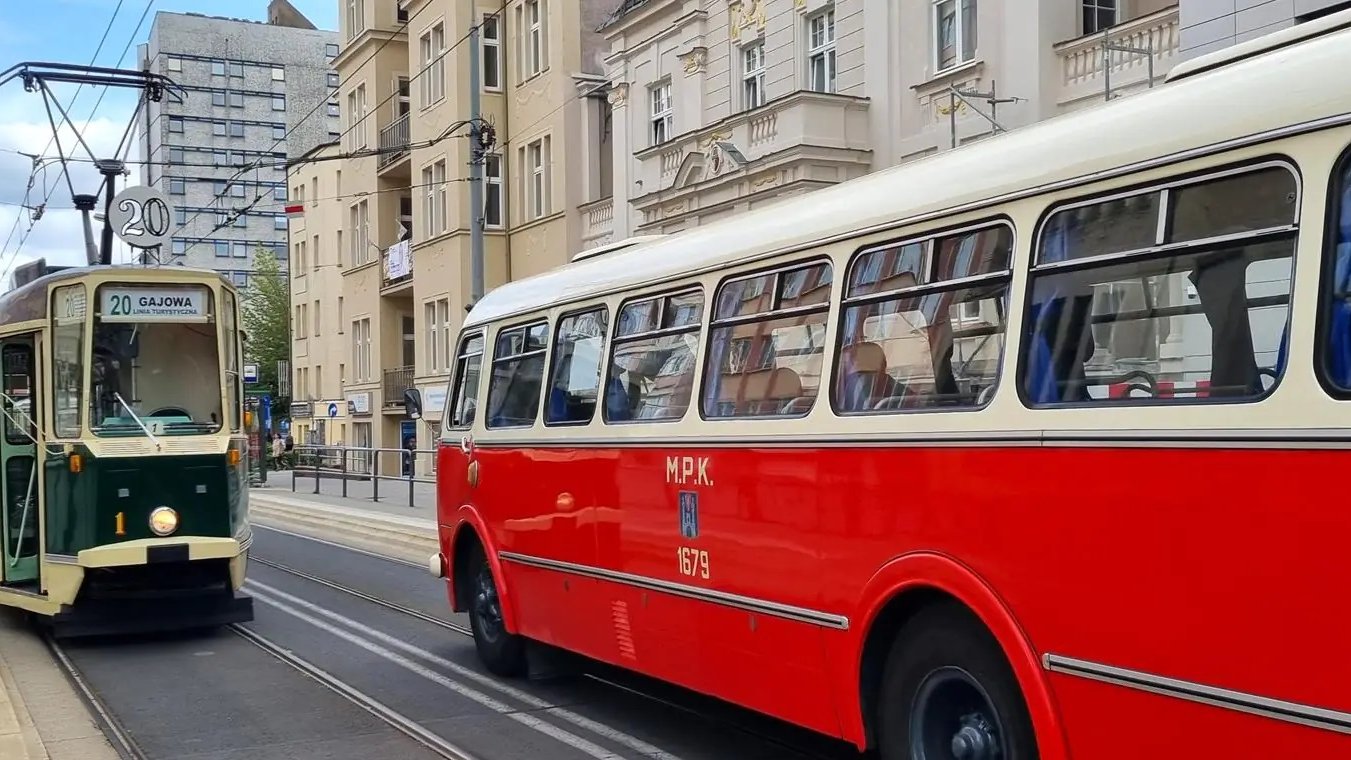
left=1055, top=5, right=1181, bottom=108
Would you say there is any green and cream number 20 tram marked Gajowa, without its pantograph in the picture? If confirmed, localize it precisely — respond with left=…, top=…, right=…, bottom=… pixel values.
left=0, top=266, right=253, bottom=637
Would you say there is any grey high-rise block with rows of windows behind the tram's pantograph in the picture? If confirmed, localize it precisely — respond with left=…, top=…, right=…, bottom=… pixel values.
left=138, top=0, right=338, bottom=286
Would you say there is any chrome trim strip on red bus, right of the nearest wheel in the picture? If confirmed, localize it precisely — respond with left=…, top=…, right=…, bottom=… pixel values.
left=1042, top=653, right=1351, bottom=733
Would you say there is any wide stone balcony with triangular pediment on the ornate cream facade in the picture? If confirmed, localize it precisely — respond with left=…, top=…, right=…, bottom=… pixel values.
left=632, top=92, right=873, bottom=228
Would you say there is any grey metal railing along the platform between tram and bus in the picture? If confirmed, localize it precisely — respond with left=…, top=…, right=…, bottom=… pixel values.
left=290, top=444, right=436, bottom=506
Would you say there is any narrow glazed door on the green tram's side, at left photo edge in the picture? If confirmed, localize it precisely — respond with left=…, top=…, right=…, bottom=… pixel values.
left=0, top=336, right=39, bottom=586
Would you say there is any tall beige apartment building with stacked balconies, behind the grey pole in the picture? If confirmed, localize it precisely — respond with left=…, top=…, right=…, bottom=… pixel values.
left=298, top=0, right=613, bottom=472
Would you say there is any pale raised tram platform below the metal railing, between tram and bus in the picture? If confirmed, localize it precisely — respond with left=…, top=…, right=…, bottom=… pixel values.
left=249, top=472, right=440, bottom=566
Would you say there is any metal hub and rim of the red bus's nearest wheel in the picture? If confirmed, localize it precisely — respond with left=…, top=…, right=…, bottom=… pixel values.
left=911, top=667, right=1005, bottom=760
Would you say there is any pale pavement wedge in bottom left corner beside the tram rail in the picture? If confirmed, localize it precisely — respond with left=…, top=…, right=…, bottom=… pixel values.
left=0, top=609, right=118, bottom=760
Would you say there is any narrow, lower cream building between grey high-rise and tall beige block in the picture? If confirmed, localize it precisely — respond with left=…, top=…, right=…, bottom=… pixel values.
left=286, top=142, right=351, bottom=445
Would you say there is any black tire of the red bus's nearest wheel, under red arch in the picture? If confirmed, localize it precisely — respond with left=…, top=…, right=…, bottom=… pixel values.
left=875, top=603, right=1038, bottom=760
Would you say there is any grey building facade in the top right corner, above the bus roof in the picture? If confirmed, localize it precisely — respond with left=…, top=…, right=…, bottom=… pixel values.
left=1178, top=0, right=1351, bottom=59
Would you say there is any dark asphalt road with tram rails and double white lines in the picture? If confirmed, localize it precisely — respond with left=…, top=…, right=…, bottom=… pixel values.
left=55, top=526, right=859, bottom=760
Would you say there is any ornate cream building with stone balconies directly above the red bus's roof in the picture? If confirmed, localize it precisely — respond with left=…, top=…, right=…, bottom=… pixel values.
left=599, top=0, right=1178, bottom=247
